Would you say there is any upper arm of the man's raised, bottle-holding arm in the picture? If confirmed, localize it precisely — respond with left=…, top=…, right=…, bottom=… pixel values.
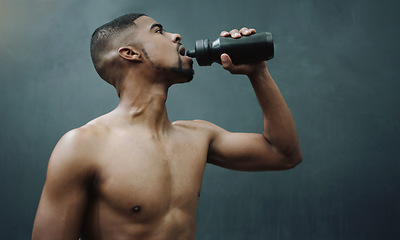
left=208, top=123, right=301, bottom=171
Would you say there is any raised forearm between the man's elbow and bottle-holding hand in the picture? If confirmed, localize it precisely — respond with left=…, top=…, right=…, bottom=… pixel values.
left=249, top=63, right=301, bottom=156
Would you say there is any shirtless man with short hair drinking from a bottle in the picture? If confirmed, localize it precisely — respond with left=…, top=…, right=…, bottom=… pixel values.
left=33, top=14, right=302, bottom=240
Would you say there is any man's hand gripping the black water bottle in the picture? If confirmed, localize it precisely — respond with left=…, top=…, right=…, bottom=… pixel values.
left=220, top=27, right=267, bottom=77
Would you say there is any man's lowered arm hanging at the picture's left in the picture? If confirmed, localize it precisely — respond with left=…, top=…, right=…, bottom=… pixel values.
left=32, top=130, right=94, bottom=240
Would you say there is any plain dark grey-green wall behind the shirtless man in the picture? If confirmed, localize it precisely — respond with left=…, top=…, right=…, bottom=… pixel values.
left=0, top=0, right=400, bottom=240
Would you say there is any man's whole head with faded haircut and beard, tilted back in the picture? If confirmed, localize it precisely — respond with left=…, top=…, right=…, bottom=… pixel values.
left=90, top=13, right=193, bottom=93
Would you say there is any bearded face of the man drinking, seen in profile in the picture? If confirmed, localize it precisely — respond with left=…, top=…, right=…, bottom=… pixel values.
left=131, top=16, right=194, bottom=83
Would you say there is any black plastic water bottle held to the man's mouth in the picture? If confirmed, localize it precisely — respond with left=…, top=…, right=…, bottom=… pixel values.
left=186, top=32, right=274, bottom=66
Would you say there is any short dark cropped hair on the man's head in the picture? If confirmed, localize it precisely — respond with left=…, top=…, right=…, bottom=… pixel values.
left=90, top=13, right=146, bottom=87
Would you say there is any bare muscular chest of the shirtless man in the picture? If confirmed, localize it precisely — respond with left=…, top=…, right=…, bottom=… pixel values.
left=90, top=132, right=208, bottom=217
